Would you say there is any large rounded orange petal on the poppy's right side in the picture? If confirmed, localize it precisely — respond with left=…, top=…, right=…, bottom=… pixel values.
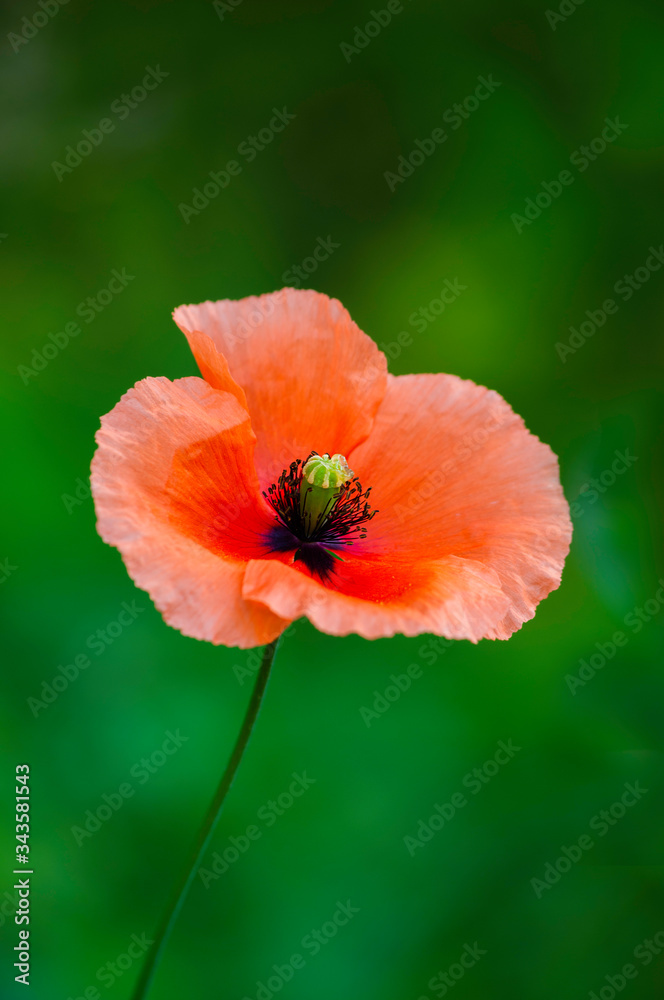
left=347, top=375, right=572, bottom=639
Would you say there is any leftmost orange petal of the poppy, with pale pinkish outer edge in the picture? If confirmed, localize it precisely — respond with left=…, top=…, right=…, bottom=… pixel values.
left=92, top=378, right=288, bottom=649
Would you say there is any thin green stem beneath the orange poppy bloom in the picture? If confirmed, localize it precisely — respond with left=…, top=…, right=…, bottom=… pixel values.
left=132, top=639, right=279, bottom=1000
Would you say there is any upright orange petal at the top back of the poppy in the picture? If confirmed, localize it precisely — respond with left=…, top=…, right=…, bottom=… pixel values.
left=173, top=288, right=387, bottom=489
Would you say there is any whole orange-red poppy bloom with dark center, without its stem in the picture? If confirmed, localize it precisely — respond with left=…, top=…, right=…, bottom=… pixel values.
left=92, top=289, right=571, bottom=648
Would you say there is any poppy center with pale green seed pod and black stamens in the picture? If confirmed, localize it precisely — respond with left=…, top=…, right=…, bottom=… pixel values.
left=263, top=451, right=378, bottom=579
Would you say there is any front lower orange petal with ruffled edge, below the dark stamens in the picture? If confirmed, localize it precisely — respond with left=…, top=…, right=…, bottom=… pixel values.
left=242, top=552, right=509, bottom=642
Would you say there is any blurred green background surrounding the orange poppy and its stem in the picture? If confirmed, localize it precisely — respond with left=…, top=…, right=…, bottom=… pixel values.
left=0, top=0, right=664, bottom=1000
